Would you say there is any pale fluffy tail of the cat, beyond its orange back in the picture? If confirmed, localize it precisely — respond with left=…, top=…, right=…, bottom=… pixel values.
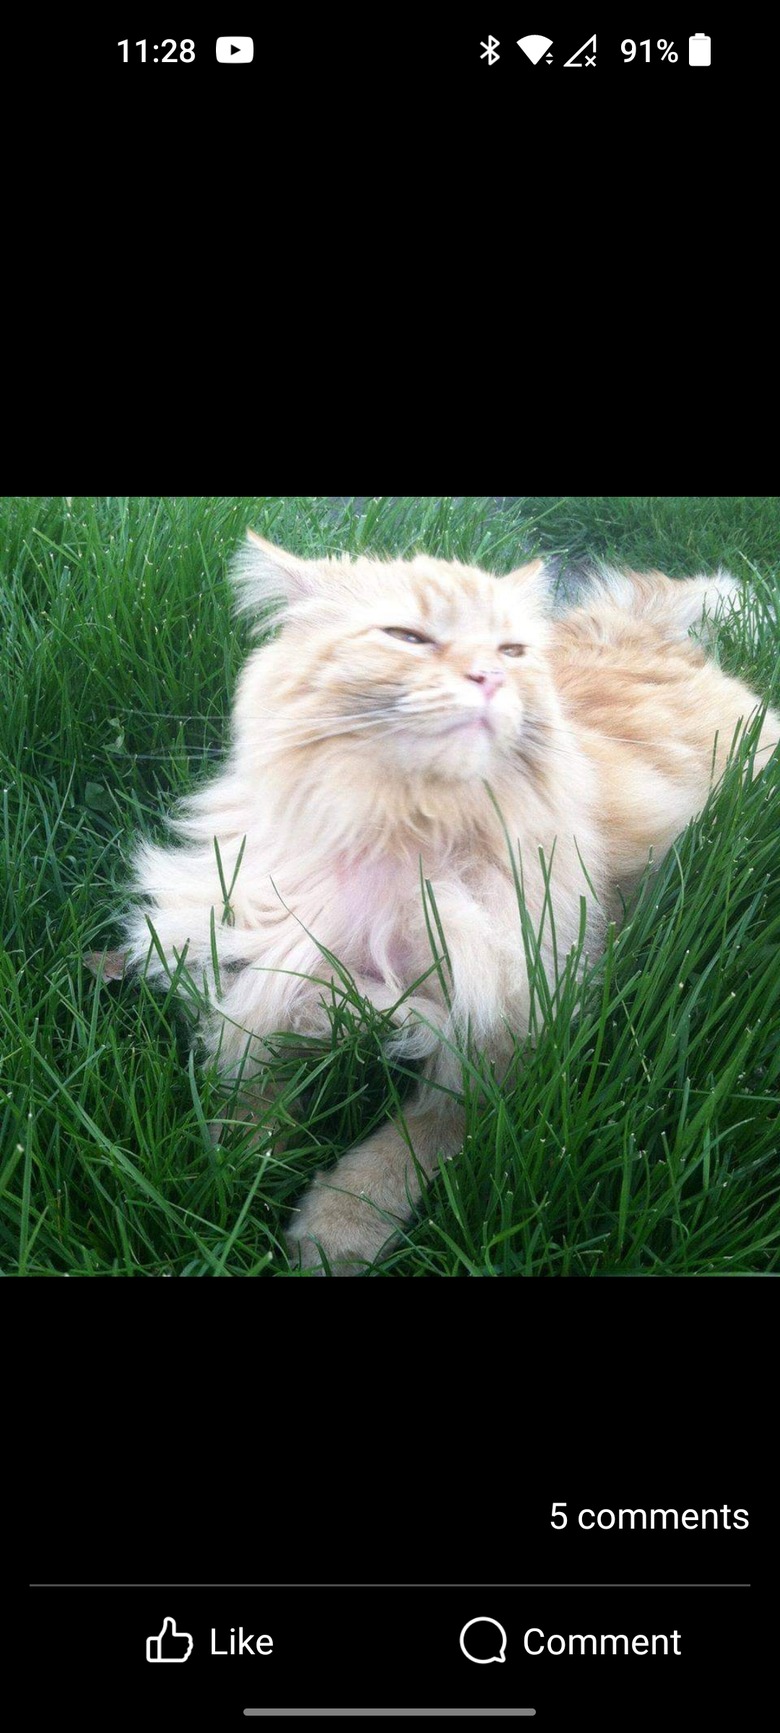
left=586, top=567, right=742, bottom=639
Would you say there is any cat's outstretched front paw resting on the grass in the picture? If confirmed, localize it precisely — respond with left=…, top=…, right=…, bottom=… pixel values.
left=288, top=1172, right=409, bottom=1275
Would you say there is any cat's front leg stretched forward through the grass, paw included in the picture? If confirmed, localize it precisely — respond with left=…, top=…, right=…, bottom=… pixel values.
left=288, top=1092, right=463, bottom=1275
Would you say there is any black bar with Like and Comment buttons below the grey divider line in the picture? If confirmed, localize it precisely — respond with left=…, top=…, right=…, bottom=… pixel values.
left=33, top=1587, right=761, bottom=1730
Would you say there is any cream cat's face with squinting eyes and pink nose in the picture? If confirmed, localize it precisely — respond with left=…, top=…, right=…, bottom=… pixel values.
left=234, top=544, right=548, bottom=780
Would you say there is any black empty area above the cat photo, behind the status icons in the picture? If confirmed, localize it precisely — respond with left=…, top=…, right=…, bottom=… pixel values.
left=0, top=5, right=778, bottom=454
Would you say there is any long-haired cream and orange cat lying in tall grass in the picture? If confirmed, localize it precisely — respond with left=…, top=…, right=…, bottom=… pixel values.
left=118, top=534, right=780, bottom=1274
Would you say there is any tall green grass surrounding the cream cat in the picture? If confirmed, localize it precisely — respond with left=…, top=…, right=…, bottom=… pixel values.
left=0, top=497, right=780, bottom=1279
